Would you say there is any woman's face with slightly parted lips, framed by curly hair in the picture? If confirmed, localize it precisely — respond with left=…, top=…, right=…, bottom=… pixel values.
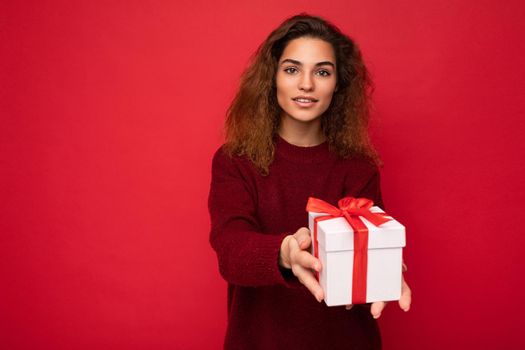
left=275, top=37, right=337, bottom=123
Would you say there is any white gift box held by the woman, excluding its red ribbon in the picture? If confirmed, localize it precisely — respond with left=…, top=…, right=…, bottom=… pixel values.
left=308, top=206, right=405, bottom=306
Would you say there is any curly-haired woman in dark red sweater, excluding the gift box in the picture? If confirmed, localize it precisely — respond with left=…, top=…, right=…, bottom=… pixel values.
left=209, top=14, right=411, bottom=349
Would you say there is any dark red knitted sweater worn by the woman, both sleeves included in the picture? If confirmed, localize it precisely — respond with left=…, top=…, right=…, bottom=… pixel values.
left=209, top=136, right=383, bottom=350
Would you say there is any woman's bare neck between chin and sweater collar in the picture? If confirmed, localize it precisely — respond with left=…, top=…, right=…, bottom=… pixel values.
left=278, top=117, right=326, bottom=147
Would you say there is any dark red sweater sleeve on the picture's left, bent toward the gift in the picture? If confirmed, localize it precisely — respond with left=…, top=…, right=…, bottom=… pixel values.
left=208, top=149, right=288, bottom=287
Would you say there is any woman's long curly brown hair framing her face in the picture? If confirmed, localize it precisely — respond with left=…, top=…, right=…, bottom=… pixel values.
left=224, top=13, right=381, bottom=175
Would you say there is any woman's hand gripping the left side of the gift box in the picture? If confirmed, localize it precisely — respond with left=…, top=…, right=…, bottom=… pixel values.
left=279, top=227, right=324, bottom=302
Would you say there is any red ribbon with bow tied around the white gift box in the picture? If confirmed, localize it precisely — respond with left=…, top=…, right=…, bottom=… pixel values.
left=306, top=197, right=391, bottom=304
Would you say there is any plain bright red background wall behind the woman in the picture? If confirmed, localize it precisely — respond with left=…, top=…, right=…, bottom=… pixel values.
left=0, top=0, right=525, bottom=349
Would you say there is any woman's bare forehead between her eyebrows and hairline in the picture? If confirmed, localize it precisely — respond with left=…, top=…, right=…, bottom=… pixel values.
left=279, top=37, right=335, bottom=64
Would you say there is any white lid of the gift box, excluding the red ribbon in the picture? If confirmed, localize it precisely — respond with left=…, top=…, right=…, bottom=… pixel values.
left=308, top=206, right=405, bottom=252
